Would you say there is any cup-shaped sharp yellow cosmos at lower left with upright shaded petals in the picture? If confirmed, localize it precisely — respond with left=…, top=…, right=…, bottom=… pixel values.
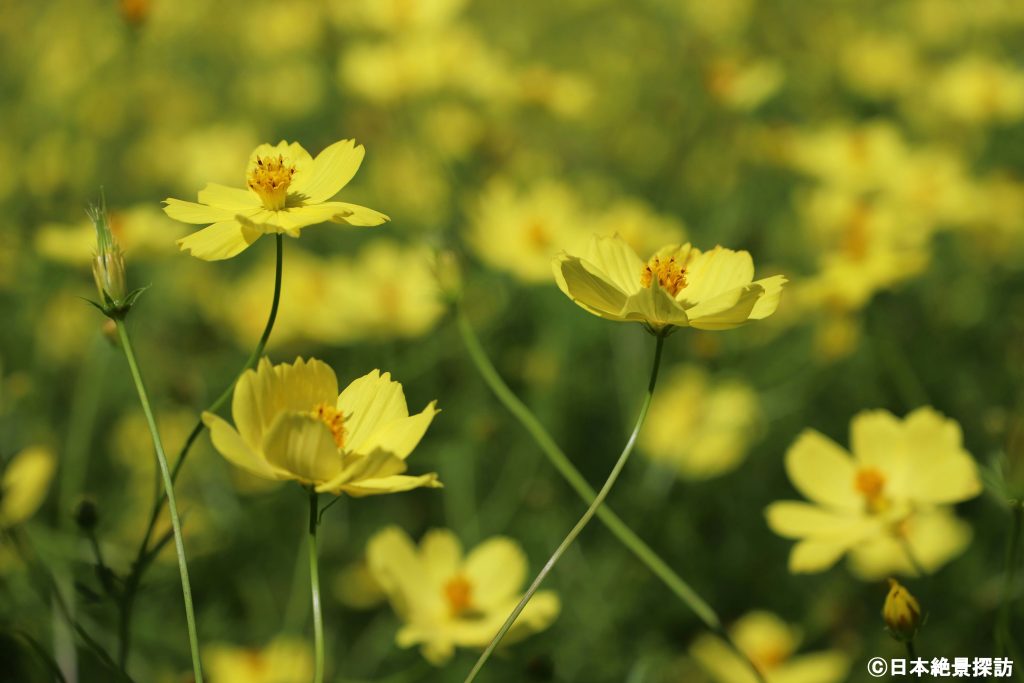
left=203, top=358, right=440, bottom=497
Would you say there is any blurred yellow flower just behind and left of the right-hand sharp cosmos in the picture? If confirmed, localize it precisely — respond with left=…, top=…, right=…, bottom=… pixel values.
left=469, top=179, right=586, bottom=284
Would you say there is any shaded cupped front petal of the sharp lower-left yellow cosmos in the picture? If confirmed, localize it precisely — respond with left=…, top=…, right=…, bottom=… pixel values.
left=263, top=413, right=341, bottom=483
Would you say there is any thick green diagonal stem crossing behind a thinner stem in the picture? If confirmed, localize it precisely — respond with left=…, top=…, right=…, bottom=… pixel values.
left=456, top=306, right=764, bottom=682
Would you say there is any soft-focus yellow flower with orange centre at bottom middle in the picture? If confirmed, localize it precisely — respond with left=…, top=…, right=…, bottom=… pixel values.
left=367, top=526, right=560, bottom=665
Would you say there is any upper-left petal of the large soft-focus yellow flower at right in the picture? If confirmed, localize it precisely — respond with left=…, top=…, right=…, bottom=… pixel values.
left=785, top=429, right=863, bottom=510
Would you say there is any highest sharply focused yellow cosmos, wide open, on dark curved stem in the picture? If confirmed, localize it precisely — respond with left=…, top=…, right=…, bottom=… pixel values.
left=164, top=140, right=388, bottom=261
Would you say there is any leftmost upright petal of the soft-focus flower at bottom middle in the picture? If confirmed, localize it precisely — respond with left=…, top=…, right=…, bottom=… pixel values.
left=367, top=526, right=431, bottom=622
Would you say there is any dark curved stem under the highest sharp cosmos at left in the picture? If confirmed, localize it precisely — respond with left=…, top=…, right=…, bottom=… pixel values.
left=118, top=234, right=284, bottom=657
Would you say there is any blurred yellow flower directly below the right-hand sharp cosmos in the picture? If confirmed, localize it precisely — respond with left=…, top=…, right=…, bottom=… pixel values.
left=640, top=367, right=761, bottom=479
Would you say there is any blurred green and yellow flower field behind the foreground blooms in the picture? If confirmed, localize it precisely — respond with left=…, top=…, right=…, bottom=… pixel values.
left=0, top=0, right=1024, bottom=683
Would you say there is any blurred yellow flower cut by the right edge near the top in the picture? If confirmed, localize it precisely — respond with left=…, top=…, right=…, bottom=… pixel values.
left=931, top=54, right=1024, bottom=124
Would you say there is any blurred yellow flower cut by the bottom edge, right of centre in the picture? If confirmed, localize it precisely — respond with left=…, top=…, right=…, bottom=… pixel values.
left=690, top=611, right=850, bottom=683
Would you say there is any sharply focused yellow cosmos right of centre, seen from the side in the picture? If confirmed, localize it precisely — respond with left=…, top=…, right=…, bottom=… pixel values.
left=553, top=236, right=786, bottom=331
